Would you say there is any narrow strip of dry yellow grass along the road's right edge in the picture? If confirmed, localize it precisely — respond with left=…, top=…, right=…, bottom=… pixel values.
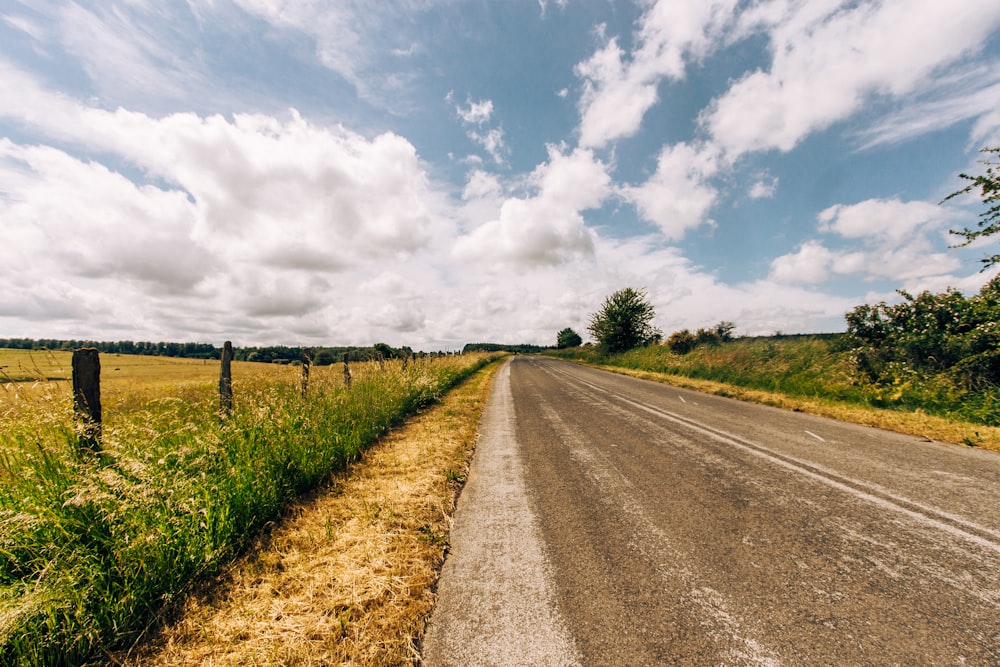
left=599, top=366, right=1000, bottom=451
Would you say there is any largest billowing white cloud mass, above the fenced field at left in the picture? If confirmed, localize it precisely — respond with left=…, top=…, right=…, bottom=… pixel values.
left=0, top=67, right=451, bottom=342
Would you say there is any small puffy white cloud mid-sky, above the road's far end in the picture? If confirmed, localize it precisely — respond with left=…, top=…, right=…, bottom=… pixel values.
left=455, top=146, right=611, bottom=266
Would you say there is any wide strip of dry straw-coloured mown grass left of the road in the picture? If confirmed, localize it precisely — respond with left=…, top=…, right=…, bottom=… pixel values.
left=119, top=364, right=497, bottom=665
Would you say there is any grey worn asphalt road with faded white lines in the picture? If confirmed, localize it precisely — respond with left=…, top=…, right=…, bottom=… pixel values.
left=423, top=357, right=1000, bottom=667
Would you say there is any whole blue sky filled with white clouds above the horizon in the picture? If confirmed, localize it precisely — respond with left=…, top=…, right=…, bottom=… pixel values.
left=0, top=0, right=1000, bottom=350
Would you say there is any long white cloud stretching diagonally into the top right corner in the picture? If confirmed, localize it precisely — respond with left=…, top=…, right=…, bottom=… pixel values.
left=701, top=0, right=1000, bottom=158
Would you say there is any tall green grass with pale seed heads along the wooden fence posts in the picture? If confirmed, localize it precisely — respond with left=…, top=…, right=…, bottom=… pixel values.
left=0, top=355, right=498, bottom=665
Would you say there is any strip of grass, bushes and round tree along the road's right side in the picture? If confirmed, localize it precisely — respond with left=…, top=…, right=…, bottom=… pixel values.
left=549, top=277, right=1000, bottom=448
